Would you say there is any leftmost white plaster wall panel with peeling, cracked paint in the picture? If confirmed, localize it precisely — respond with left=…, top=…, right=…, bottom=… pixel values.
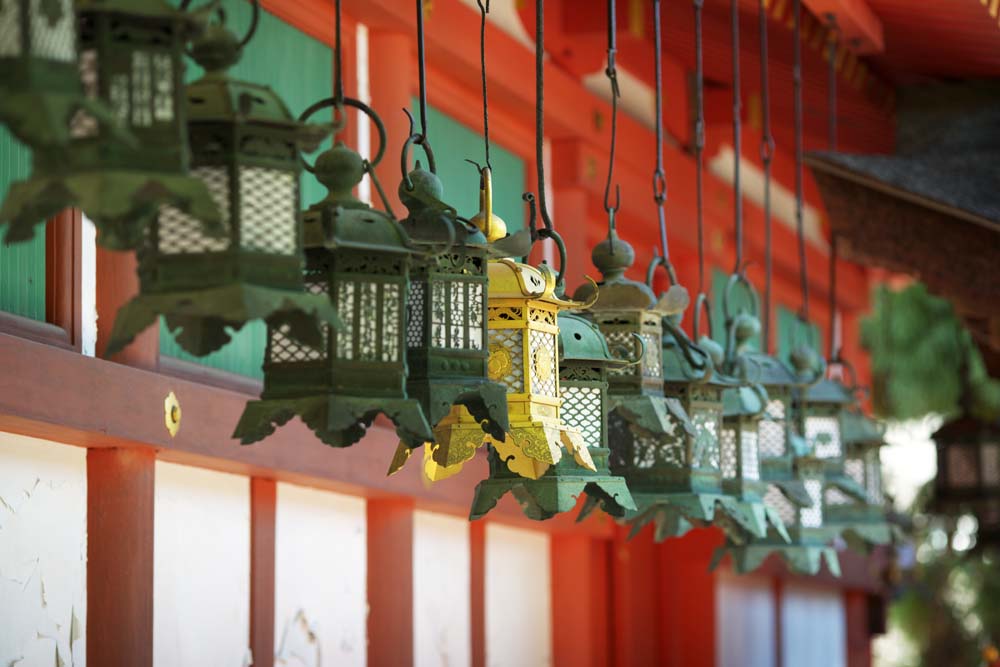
left=0, top=432, right=87, bottom=667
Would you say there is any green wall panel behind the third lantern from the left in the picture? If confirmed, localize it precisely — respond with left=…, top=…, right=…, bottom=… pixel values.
left=160, top=0, right=333, bottom=378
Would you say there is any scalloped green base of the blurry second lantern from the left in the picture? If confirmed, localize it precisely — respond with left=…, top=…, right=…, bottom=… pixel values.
left=0, top=168, right=221, bottom=250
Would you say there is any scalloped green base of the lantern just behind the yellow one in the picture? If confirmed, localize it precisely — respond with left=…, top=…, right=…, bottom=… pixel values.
left=469, top=449, right=636, bottom=521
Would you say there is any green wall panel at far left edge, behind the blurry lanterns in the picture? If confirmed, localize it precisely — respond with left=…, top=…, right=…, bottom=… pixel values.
left=0, top=128, right=45, bottom=321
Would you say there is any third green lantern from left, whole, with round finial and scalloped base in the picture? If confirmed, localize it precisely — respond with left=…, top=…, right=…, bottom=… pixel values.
left=108, top=10, right=338, bottom=356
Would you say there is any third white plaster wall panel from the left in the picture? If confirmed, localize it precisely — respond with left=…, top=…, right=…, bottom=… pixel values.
left=274, top=484, right=368, bottom=667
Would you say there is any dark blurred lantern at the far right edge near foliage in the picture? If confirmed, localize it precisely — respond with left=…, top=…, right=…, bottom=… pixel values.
left=933, top=413, right=1000, bottom=548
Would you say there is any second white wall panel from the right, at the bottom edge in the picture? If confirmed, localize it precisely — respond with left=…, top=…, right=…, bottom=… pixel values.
left=715, top=573, right=777, bottom=667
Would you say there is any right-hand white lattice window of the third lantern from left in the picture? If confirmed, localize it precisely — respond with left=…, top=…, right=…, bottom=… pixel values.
left=239, top=167, right=299, bottom=255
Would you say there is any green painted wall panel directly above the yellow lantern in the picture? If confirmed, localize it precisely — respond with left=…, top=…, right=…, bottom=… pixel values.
left=410, top=100, right=528, bottom=232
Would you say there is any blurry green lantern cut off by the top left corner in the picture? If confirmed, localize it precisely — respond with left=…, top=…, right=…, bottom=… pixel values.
left=0, top=0, right=122, bottom=150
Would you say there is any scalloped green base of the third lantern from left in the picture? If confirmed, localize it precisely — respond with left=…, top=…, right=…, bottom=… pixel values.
left=105, top=284, right=342, bottom=357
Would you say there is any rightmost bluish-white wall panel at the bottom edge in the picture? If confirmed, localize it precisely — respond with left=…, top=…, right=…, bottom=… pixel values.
left=781, top=583, right=847, bottom=667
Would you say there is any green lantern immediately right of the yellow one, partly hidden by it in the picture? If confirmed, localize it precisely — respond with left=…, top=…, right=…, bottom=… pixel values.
left=471, top=313, right=636, bottom=520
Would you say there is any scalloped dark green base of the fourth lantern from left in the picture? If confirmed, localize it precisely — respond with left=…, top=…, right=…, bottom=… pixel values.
left=233, top=394, right=431, bottom=447
